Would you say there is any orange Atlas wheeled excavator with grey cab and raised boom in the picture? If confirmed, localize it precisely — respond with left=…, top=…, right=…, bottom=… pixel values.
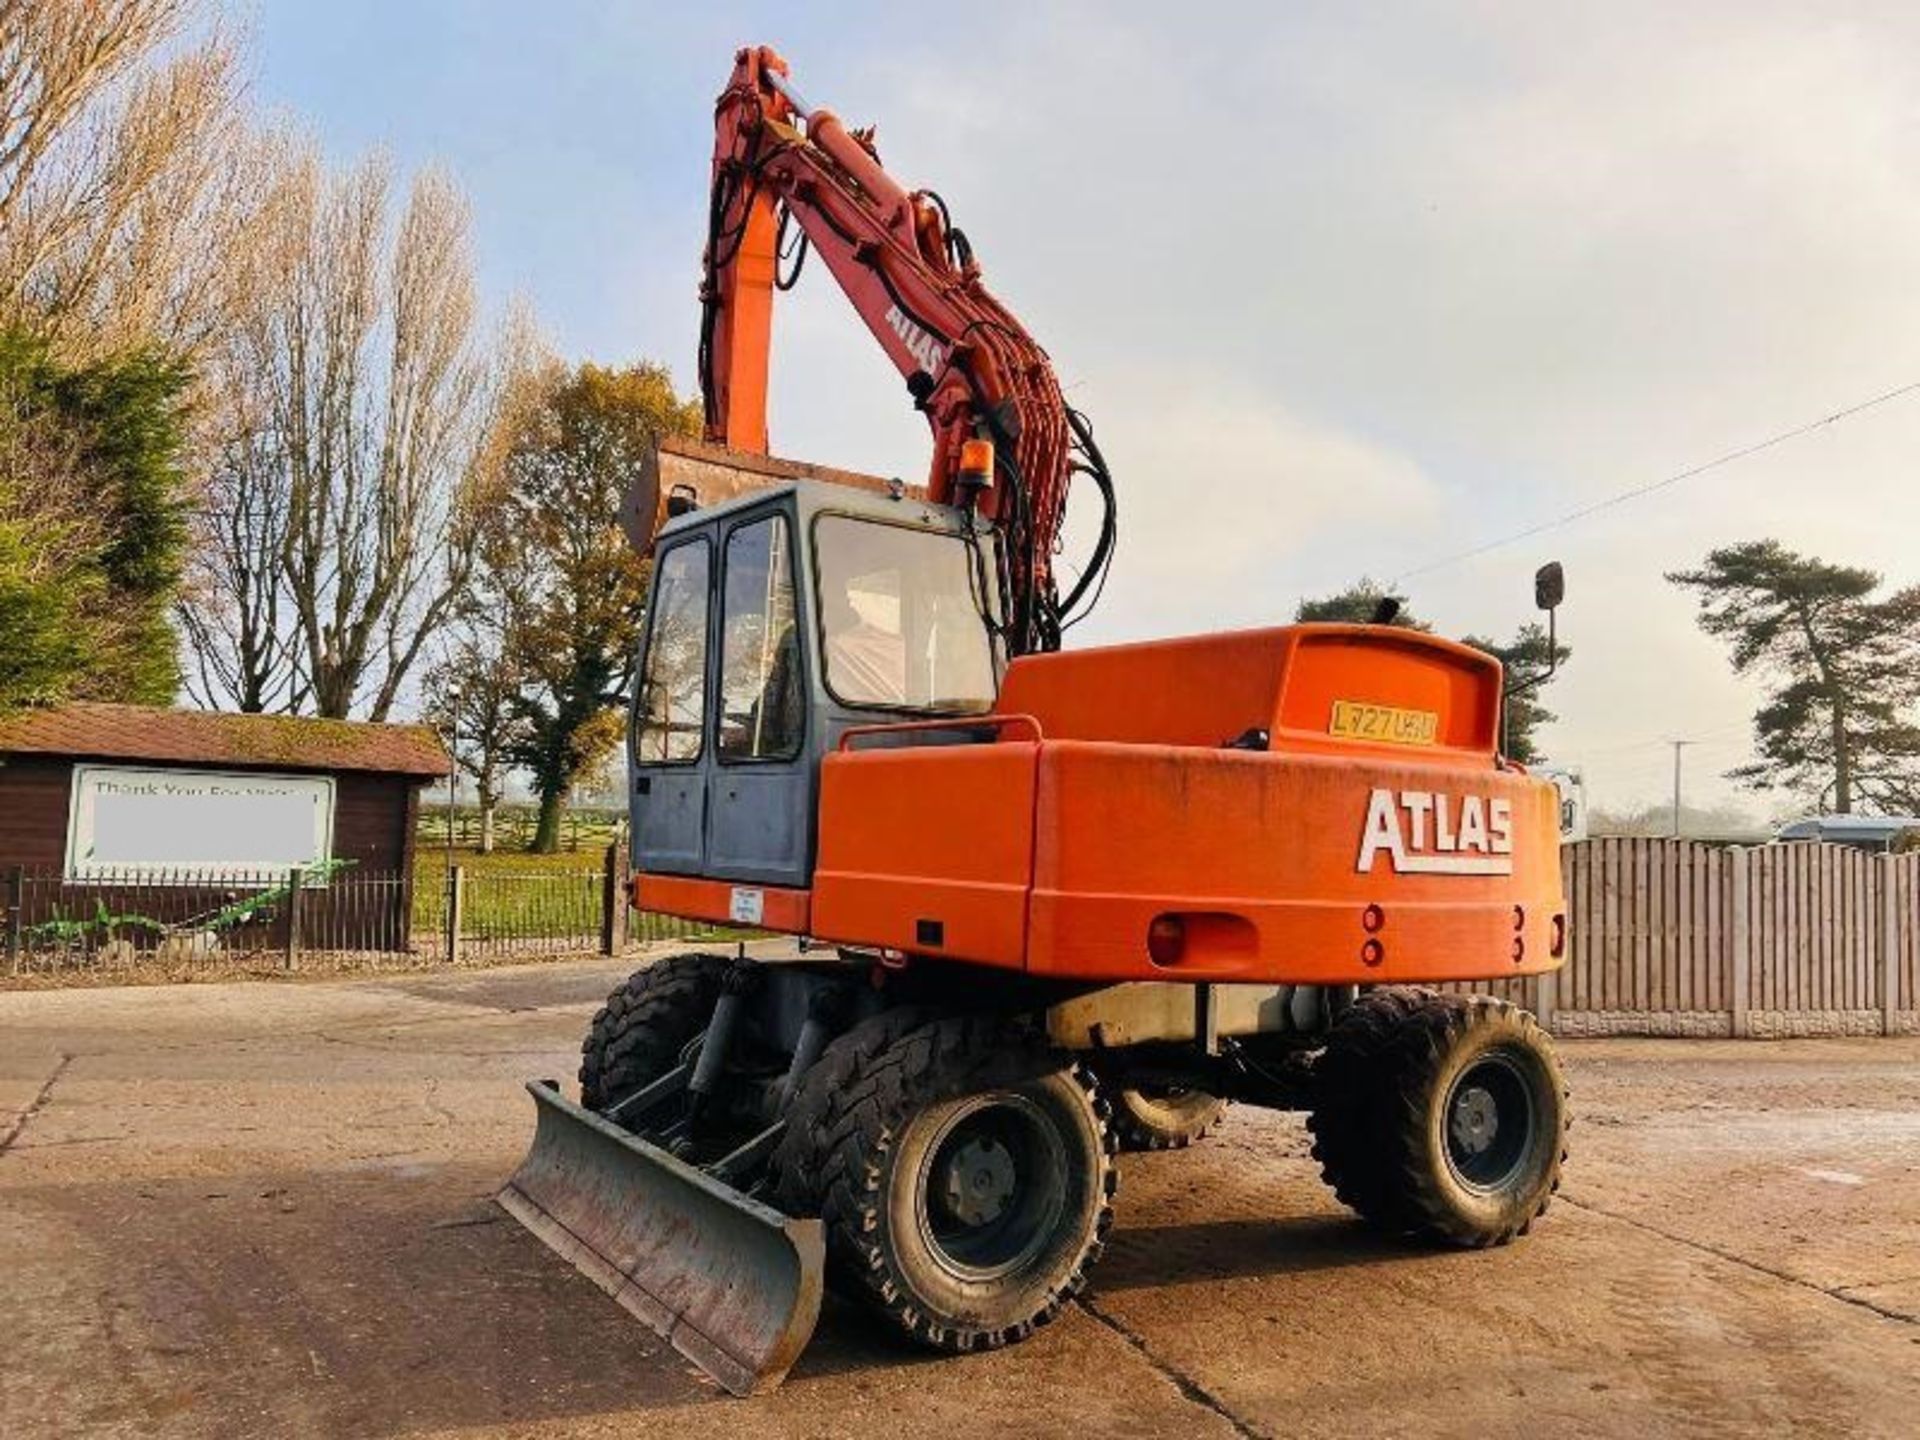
left=501, top=48, right=1567, bottom=1392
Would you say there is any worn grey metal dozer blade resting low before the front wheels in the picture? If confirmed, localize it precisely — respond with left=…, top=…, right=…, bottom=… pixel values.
left=497, top=1081, right=826, bottom=1396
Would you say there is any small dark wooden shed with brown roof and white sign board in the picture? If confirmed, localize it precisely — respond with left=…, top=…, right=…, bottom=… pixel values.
left=0, top=703, right=451, bottom=950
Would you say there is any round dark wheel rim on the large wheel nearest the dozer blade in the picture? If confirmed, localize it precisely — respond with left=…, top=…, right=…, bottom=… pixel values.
left=914, top=1092, right=1068, bottom=1281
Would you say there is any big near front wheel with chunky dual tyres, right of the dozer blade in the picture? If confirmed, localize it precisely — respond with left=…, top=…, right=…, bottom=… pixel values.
left=774, top=1010, right=1117, bottom=1352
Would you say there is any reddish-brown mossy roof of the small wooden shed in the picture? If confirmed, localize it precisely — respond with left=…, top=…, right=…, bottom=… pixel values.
left=0, top=701, right=453, bottom=780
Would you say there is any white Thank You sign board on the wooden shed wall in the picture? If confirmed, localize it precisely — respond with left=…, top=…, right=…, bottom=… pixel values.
left=67, top=764, right=334, bottom=883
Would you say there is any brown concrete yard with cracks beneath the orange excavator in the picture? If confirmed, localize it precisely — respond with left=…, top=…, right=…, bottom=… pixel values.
left=0, top=962, right=1920, bottom=1440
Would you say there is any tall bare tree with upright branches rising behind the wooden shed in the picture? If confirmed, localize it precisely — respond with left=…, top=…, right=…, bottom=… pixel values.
left=184, top=148, right=516, bottom=720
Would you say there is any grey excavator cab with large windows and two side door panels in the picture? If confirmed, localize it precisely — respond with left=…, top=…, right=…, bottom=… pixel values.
left=628, top=480, right=1004, bottom=898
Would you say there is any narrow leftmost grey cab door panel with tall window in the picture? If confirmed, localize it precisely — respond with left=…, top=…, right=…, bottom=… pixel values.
left=628, top=534, right=714, bottom=876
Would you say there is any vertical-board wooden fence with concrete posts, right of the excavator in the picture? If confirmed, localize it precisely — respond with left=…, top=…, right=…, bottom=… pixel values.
left=1500, top=839, right=1920, bottom=1037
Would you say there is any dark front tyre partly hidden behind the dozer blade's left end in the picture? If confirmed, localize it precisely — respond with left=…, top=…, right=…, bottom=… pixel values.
left=580, top=954, right=728, bottom=1110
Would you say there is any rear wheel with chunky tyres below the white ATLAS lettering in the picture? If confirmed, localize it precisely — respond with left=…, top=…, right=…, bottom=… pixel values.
left=1308, top=989, right=1569, bottom=1248
